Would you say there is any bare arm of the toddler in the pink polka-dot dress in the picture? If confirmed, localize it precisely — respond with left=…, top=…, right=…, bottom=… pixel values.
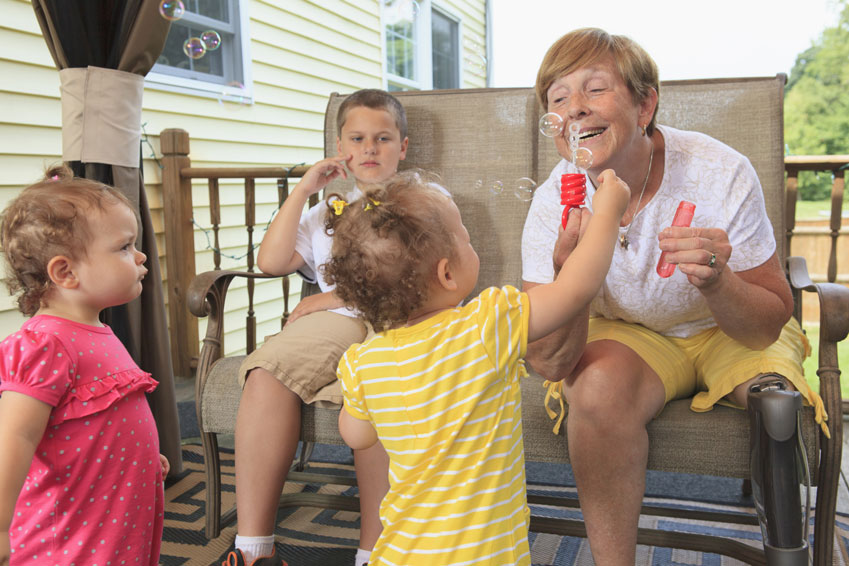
left=0, top=391, right=52, bottom=566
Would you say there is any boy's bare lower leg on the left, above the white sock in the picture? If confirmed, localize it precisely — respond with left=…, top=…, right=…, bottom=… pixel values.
left=236, top=368, right=301, bottom=537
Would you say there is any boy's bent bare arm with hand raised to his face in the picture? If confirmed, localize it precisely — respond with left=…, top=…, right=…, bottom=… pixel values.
left=256, top=155, right=351, bottom=275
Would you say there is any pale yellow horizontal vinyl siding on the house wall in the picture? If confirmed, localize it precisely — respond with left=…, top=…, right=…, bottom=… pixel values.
left=0, top=0, right=486, bottom=362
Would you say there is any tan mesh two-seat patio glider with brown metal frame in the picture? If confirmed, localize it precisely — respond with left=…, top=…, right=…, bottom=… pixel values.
left=188, top=75, right=849, bottom=565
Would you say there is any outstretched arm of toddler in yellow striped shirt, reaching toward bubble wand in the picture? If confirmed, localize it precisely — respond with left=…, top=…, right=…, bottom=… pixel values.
left=528, top=169, right=631, bottom=342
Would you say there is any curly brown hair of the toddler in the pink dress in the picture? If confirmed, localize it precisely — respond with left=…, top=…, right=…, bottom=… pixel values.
left=0, top=165, right=134, bottom=316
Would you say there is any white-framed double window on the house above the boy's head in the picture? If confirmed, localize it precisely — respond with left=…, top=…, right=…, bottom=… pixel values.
left=382, top=0, right=461, bottom=91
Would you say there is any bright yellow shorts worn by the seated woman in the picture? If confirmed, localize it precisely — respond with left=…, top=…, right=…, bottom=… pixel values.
left=587, top=317, right=827, bottom=432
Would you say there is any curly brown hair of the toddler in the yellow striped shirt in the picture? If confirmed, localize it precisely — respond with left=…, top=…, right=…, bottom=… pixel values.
left=322, top=171, right=455, bottom=331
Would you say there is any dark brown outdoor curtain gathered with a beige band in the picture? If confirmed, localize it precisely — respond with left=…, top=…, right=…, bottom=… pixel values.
left=32, top=0, right=182, bottom=474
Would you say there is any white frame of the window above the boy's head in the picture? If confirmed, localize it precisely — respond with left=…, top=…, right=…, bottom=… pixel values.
left=380, top=0, right=464, bottom=90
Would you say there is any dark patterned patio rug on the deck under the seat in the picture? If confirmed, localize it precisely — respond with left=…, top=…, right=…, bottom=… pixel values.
left=160, top=445, right=849, bottom=566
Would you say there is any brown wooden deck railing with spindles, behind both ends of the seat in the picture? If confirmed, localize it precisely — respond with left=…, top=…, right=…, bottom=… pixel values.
left=159, top=129, right=849, bottom=376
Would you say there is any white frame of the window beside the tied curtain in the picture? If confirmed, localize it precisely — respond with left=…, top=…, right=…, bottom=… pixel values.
left=145, top=0, right=253, bottom=104
